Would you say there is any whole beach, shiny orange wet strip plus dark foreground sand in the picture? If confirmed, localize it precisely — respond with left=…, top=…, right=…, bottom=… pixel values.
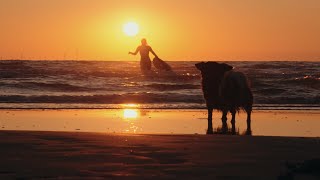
left=0, top=109, right=320, bottom=180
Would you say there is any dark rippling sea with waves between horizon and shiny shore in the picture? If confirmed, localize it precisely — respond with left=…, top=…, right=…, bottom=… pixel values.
left=0, top=60, right=320, bottom=109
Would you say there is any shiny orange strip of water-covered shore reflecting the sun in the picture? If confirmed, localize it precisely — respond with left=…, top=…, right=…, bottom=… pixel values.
left=0, top=107, right=320, bottom=137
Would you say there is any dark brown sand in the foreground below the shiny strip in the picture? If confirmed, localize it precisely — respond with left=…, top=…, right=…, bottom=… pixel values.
left=0, top=131, right=320, bottom=180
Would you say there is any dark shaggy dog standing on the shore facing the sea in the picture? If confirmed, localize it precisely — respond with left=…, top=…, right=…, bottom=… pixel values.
left=195, top=62, right=253, bottom=134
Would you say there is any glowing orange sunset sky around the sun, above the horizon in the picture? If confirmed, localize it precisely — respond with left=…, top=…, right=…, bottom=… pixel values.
left=0, top=0, right=320, bottom=61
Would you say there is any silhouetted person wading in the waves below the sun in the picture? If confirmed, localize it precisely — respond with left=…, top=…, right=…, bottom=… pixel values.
left=129, top=39, right=158, bottom=72
